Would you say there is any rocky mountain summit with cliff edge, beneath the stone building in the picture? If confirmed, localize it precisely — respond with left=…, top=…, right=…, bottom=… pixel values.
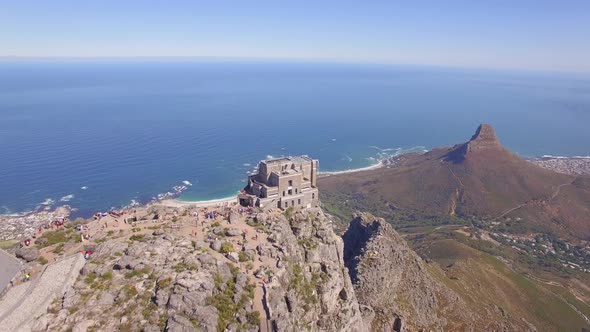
left=0, top=202, right=380, bottom=331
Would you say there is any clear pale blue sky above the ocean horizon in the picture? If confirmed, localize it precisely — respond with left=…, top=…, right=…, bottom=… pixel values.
left=0, top=0, right=590, bottom=73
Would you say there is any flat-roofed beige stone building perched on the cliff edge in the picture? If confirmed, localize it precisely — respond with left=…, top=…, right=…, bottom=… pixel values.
left=238, top=156, right=319, bottom=209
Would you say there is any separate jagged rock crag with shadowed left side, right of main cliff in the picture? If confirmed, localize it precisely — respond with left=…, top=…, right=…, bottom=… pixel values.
left=343, top=213, right=470, bottom=331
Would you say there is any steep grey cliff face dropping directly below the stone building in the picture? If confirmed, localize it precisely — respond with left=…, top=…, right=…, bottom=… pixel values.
left=261, top=209, right=368, bottom=331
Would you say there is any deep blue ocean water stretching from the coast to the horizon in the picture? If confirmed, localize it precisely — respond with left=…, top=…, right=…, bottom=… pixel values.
left=0, top=60, right=590, bottom=215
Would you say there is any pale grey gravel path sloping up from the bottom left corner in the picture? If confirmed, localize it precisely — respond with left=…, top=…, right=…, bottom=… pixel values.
left=0, top=254, right=85, bottom=332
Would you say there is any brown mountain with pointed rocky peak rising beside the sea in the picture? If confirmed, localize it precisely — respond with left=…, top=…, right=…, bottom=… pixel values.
left=319, top=124, right=590, bottom=239
